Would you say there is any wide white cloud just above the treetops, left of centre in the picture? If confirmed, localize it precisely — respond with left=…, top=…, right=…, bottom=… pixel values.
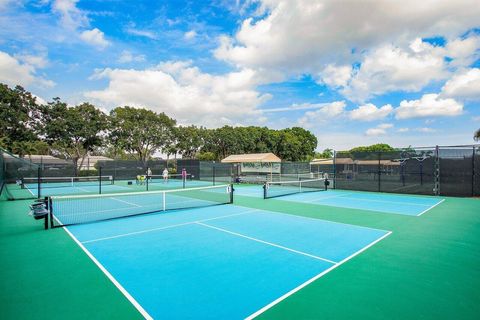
left=85, top=61, right=270, bottom=126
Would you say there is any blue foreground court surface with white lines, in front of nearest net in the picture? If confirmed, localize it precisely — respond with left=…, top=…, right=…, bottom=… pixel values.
left=67, top=205, right=390, bottom=319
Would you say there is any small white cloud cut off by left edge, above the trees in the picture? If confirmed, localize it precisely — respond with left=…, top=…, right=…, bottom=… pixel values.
left=0, top=51, right=55, bottom=87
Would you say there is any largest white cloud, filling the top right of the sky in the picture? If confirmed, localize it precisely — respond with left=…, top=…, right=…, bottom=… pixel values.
left=215, top=0, right=480, bottom=74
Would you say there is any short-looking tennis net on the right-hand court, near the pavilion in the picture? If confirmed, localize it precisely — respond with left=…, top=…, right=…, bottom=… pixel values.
left=263, top=179, right=327, bottom=199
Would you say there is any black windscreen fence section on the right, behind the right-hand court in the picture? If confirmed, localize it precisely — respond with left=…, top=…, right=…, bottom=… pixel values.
left=334, top=145, right=480, bottom=197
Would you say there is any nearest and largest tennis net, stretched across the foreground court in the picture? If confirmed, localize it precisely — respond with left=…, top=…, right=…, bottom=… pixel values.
left=48, top=185, right=233, bottom=228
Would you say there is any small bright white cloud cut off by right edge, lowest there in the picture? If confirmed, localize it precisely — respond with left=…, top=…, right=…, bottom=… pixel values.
left=442, top=68, right=480, bottom=100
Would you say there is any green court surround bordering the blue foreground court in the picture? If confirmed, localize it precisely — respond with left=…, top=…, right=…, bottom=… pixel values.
left=0, top=186, right=480, bottom=319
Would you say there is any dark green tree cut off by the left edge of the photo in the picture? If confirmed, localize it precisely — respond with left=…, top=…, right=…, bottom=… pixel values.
left=0, top=84, right=39, bottom=157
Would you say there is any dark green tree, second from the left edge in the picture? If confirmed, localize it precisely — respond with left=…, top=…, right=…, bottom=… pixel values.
left=41, top=98, right=107, bottom=175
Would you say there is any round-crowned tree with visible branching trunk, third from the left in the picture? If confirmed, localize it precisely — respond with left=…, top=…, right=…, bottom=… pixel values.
left=109, top=106, right=176, bottom=166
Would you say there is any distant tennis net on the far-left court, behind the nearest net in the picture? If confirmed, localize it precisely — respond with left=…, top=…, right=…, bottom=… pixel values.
left=22, top=176, right=113, bottom=189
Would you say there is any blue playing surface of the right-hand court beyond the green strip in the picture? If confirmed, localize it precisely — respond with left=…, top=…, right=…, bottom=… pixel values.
left=235, top=186, right=443, bottom=216
